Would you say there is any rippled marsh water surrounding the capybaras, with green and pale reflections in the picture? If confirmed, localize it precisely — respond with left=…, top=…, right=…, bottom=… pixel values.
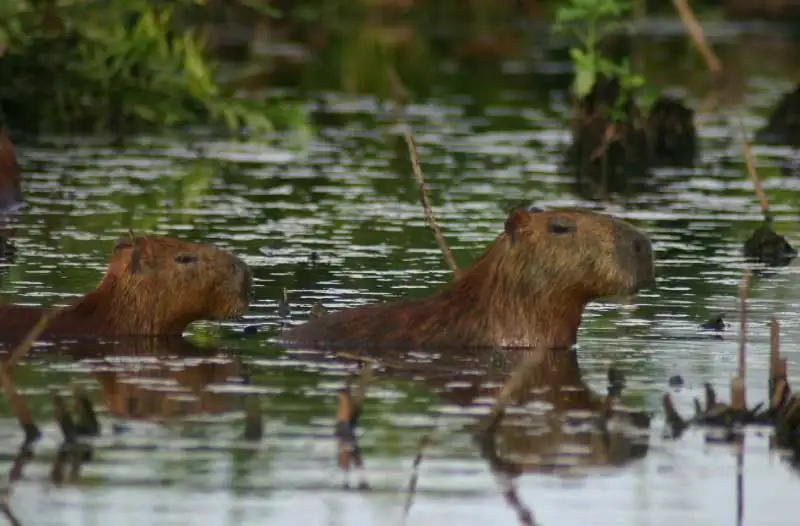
left=0, top=18, right=800, bottom=525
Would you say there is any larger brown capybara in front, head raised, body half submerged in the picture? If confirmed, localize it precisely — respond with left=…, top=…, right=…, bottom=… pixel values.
left=279, top=208, right=655, bottom=349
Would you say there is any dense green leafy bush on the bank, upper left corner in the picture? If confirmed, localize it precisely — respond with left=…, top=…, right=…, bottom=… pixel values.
left=0, top=0, right=288, bottom=138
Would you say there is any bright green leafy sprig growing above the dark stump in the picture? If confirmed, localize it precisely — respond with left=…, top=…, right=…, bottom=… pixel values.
left=553, top=0, right=645, bottom=103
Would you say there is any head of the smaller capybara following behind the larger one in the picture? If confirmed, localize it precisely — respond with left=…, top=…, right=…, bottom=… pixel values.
left=79, top=233, right=251, bottom=334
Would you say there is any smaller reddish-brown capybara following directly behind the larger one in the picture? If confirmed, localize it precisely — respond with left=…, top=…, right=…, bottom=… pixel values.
left=0, top=236, right=251, bottom=338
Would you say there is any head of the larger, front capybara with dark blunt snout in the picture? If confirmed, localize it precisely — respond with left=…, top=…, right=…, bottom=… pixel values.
left=504, top=208, right=655, bottom=301
